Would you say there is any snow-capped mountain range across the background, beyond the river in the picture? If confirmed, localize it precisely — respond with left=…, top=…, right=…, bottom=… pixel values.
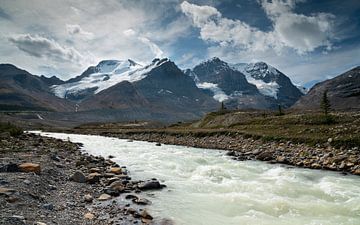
left=0, top=57, right=359, bottom=122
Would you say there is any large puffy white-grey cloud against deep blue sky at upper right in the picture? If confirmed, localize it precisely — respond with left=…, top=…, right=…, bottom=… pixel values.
left=180, top=0, right=334, bottom=53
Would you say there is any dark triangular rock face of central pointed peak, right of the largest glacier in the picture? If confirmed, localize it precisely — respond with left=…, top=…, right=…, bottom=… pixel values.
left=133, top=61, right=217, bottom=118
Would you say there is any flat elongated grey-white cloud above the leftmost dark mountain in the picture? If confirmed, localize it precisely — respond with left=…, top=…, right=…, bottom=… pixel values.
left=9, top=34, right=84, bottom=64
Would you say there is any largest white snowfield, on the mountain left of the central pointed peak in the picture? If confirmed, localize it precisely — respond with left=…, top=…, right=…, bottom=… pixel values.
left=52, top=59, right=168, bottom=98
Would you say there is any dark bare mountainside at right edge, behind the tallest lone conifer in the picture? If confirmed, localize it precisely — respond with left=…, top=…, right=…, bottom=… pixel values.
left=293, top=66, right=360, bottom=110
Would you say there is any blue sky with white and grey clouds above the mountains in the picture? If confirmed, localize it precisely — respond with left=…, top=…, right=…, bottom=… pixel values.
left=0, top=0, right=360, bottom=85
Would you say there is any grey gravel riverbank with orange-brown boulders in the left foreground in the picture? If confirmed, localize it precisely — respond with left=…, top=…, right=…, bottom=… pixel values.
left=0, top=134, right=171, bottom=225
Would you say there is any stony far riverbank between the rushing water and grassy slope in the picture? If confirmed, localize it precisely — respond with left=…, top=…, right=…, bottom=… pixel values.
left=97, top=131, right=360, bottom=175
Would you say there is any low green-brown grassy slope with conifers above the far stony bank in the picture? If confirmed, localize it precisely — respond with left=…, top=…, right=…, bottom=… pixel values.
left=187, top=111, right=360, bottom=147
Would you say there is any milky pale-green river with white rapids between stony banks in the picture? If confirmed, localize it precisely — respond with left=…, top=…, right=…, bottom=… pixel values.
left=34, top=133, right=360, bottom=225
